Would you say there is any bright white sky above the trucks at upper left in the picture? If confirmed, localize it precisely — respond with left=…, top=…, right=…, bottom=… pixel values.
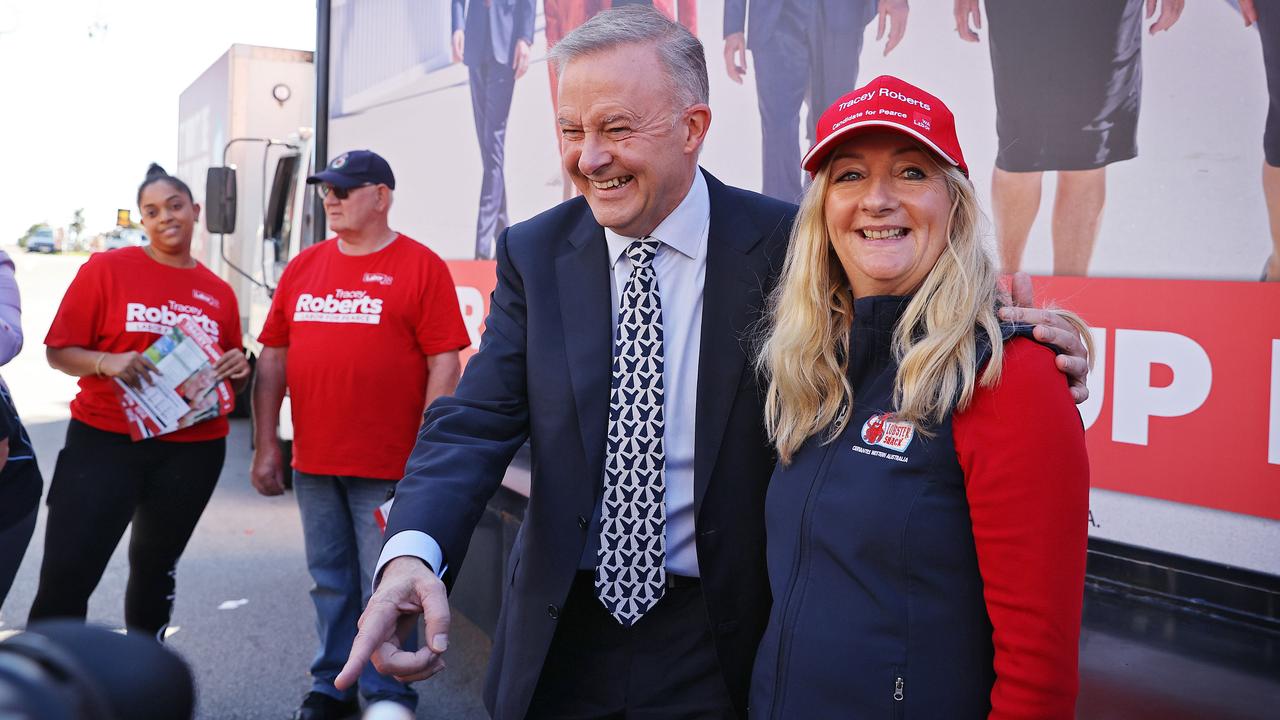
left=0, top=0, right=316, bottom=245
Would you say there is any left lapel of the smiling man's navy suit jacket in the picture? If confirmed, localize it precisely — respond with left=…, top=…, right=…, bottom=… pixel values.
left=556, top=210, right=613, bottom=487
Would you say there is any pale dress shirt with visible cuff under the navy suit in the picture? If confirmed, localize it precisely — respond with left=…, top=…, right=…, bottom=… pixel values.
left=374, top=170, right=712, bottom=583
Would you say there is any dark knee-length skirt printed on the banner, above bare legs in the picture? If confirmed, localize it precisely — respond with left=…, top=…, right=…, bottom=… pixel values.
left=987, top=0, right=1143, bottom=173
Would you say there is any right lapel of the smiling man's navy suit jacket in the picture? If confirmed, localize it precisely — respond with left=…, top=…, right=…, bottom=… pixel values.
left=694, top=173, right=767, bottom=514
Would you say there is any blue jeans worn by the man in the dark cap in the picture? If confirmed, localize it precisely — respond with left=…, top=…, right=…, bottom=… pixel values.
left=293, top=470, right=417, bottom=708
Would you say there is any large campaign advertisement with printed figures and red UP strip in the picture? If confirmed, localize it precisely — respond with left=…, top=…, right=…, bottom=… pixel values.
left=328, top=0, right=1280, bottom=575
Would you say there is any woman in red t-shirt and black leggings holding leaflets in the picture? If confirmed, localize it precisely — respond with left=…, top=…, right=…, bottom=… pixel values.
left=31, top=165, right=250, bottom=639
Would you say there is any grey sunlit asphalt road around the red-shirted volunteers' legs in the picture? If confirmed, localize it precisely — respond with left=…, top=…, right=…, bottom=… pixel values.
left=0, top=247, right=489, bottom=720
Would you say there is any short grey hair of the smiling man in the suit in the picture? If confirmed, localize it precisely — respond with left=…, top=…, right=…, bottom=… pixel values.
left=548, top=5, right=710, bottom=109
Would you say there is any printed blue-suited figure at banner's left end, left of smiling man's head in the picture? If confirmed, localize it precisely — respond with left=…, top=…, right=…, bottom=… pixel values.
left=452, top=0, right=536, bottom=258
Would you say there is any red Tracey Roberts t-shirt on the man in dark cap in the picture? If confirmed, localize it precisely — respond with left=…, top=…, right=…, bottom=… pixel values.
left=259, top=234, right=471, bottom=480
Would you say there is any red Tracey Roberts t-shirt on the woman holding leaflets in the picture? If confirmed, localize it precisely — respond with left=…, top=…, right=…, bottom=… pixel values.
left=45, top=247, right=243, bottom=442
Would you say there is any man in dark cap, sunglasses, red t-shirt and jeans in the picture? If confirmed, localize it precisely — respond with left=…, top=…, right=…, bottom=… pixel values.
left=252, top=150, right=470, bottom=720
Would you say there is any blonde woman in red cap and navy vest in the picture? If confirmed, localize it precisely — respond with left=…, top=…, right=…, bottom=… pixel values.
left=750, top=77, right=1089, bottom=720
